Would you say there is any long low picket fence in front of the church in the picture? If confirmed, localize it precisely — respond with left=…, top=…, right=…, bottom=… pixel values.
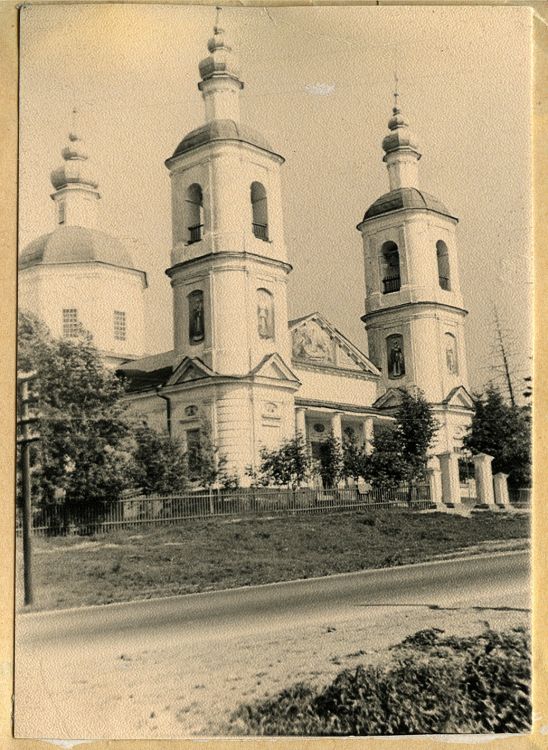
left=17, top=485, right=432, bottom=536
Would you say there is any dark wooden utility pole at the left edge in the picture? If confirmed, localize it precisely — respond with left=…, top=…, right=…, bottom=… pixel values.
left=17, top=372, right=40, bottom=605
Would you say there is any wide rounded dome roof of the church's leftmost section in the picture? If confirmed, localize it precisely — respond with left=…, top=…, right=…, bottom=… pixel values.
left=19, top=226, right=141, bottom=270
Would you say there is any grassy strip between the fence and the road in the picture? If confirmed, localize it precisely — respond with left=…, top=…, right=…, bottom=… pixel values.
left=18, top=510, right=529, bottom=609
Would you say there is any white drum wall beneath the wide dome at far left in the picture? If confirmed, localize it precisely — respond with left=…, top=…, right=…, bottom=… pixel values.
left=19, top=263, right=145, bottom=359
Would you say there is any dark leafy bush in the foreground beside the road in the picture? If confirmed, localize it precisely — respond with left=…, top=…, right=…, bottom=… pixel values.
left=225, top=628, right=531, bottom=736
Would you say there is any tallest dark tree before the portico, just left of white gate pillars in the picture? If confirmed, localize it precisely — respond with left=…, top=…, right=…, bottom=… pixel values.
left=365, top=389, right=438, bottom=486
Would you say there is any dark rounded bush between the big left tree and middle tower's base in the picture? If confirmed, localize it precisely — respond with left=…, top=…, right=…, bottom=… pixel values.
left=134, top=424, right=188, bottom=495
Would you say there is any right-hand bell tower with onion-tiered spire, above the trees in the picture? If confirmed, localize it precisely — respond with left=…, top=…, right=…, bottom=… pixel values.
left=358, top=94, right=471, bottom=450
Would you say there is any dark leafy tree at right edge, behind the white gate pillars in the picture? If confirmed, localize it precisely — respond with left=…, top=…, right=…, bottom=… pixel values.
left=463, top=385, right=531, bottom=487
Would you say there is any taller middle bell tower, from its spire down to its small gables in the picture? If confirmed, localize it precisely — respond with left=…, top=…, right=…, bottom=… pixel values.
left=166, top=9, right=291, bottom=376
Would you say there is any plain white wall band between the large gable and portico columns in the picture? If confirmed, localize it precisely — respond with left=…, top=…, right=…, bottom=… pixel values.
left=292, top=363, right=377, bottom=407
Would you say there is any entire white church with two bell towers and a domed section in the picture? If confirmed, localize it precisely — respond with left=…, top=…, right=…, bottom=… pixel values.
left=19, top=19, right=472, bottom=483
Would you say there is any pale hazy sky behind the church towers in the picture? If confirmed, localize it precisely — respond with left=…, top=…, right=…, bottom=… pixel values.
left=19, top=4, right=532, bottom=391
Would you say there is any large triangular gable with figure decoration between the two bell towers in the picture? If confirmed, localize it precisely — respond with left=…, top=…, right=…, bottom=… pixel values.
left=289, top=312, right=380, bottom=376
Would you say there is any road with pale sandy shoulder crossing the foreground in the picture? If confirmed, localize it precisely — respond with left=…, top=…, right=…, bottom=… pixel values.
left=15, top=551, right=530, bottom=738
